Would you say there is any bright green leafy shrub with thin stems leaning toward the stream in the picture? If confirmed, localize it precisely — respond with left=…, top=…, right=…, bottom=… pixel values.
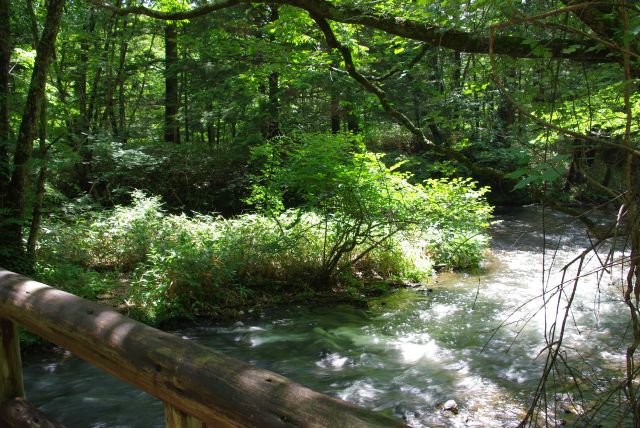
left=249, top=134, right=491, bottom=282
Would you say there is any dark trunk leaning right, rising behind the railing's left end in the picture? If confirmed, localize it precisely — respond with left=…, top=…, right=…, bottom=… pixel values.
left=0, top=0, right=64, bottom=271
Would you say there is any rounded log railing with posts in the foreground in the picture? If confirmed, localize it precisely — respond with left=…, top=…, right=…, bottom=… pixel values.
left=0, top=268, right=405, bottom=428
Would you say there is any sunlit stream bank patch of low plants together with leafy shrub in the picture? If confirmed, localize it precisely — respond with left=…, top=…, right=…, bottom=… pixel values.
left=35, top=134, right=492, bottom=322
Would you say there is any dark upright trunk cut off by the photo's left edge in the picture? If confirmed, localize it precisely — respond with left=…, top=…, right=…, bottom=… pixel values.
left=0, top=0, right=11, bottom=193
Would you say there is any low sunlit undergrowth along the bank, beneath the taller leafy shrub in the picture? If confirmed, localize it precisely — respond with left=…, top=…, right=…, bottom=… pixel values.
left=36, top=187, right=487, bottom=322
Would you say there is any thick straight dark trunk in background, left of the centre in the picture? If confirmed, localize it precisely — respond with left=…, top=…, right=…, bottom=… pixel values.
left=164, top=23, right=180, bottom=144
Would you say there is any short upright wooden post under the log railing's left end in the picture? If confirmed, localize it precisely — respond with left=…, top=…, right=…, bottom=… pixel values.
left=0, top=315, right=24, bottom=403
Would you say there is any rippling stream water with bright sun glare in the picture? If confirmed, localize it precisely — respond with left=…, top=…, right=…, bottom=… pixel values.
left=25, top=208, right=628, bottom=428
